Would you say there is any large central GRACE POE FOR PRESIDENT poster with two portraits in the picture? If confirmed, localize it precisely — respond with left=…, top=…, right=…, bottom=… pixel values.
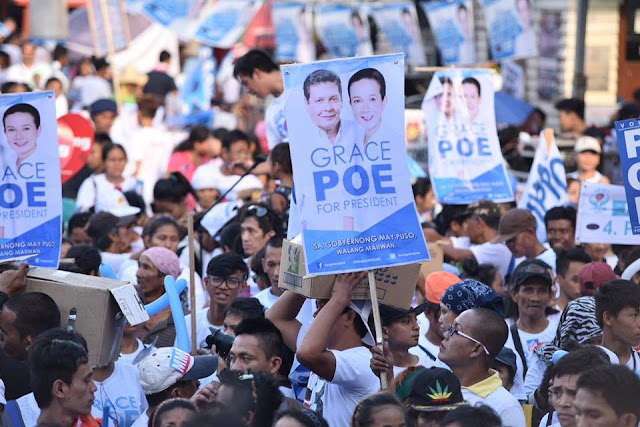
left=282, top=54, right=429, bottom=275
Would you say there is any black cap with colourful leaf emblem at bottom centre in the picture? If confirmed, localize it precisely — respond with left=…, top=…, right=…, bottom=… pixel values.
left=396, top=368, right=467, bottom=412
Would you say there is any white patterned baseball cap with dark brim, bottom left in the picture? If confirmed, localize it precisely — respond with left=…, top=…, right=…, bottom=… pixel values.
left=138, top=347, right=218, bottom=394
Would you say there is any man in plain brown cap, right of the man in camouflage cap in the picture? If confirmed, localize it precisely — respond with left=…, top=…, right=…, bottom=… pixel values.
left=492, top=209, right=556, bottom=274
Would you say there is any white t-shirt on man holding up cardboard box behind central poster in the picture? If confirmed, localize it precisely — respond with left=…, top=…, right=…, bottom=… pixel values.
left=304, top=346, right=380, bottom=426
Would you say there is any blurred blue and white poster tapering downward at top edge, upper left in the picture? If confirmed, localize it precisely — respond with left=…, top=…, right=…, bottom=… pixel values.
left=142, top=0, right=208, bottom=41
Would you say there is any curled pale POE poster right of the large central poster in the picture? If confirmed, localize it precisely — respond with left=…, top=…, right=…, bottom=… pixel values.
left=422, top=68, right=513, bottom=205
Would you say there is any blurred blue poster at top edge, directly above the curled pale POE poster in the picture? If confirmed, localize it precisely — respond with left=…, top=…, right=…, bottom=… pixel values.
left=421, top=0, right=476, bottom=65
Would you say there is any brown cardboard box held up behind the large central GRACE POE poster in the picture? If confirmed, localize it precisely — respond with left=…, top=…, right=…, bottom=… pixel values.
left=278, top=240, right=420, bottom=309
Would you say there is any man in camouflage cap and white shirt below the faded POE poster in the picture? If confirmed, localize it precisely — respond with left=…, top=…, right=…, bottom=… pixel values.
left=443, top=200, right=514, bottom=285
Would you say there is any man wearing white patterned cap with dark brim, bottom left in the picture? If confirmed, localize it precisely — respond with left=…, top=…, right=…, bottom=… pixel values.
left=131, top=347, right=218, bottom=427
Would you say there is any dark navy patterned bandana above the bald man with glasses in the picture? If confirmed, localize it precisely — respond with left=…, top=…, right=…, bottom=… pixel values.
left=440, top=279, right=505, bottom=317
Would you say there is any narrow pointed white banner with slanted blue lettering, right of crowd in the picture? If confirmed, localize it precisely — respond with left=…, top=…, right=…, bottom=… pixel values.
left=518, top=131, right=569, bottom=242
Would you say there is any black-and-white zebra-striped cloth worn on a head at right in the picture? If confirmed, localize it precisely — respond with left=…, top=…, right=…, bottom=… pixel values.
left=534, top=296, right=602, bottom=365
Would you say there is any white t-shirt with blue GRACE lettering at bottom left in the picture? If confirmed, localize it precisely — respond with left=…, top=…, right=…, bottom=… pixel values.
left=91, top=361, right=149, bottom=427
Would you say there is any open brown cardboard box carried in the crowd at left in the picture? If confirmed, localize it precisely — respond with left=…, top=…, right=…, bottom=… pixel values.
left=2, top=260, right=149, bottom=366
